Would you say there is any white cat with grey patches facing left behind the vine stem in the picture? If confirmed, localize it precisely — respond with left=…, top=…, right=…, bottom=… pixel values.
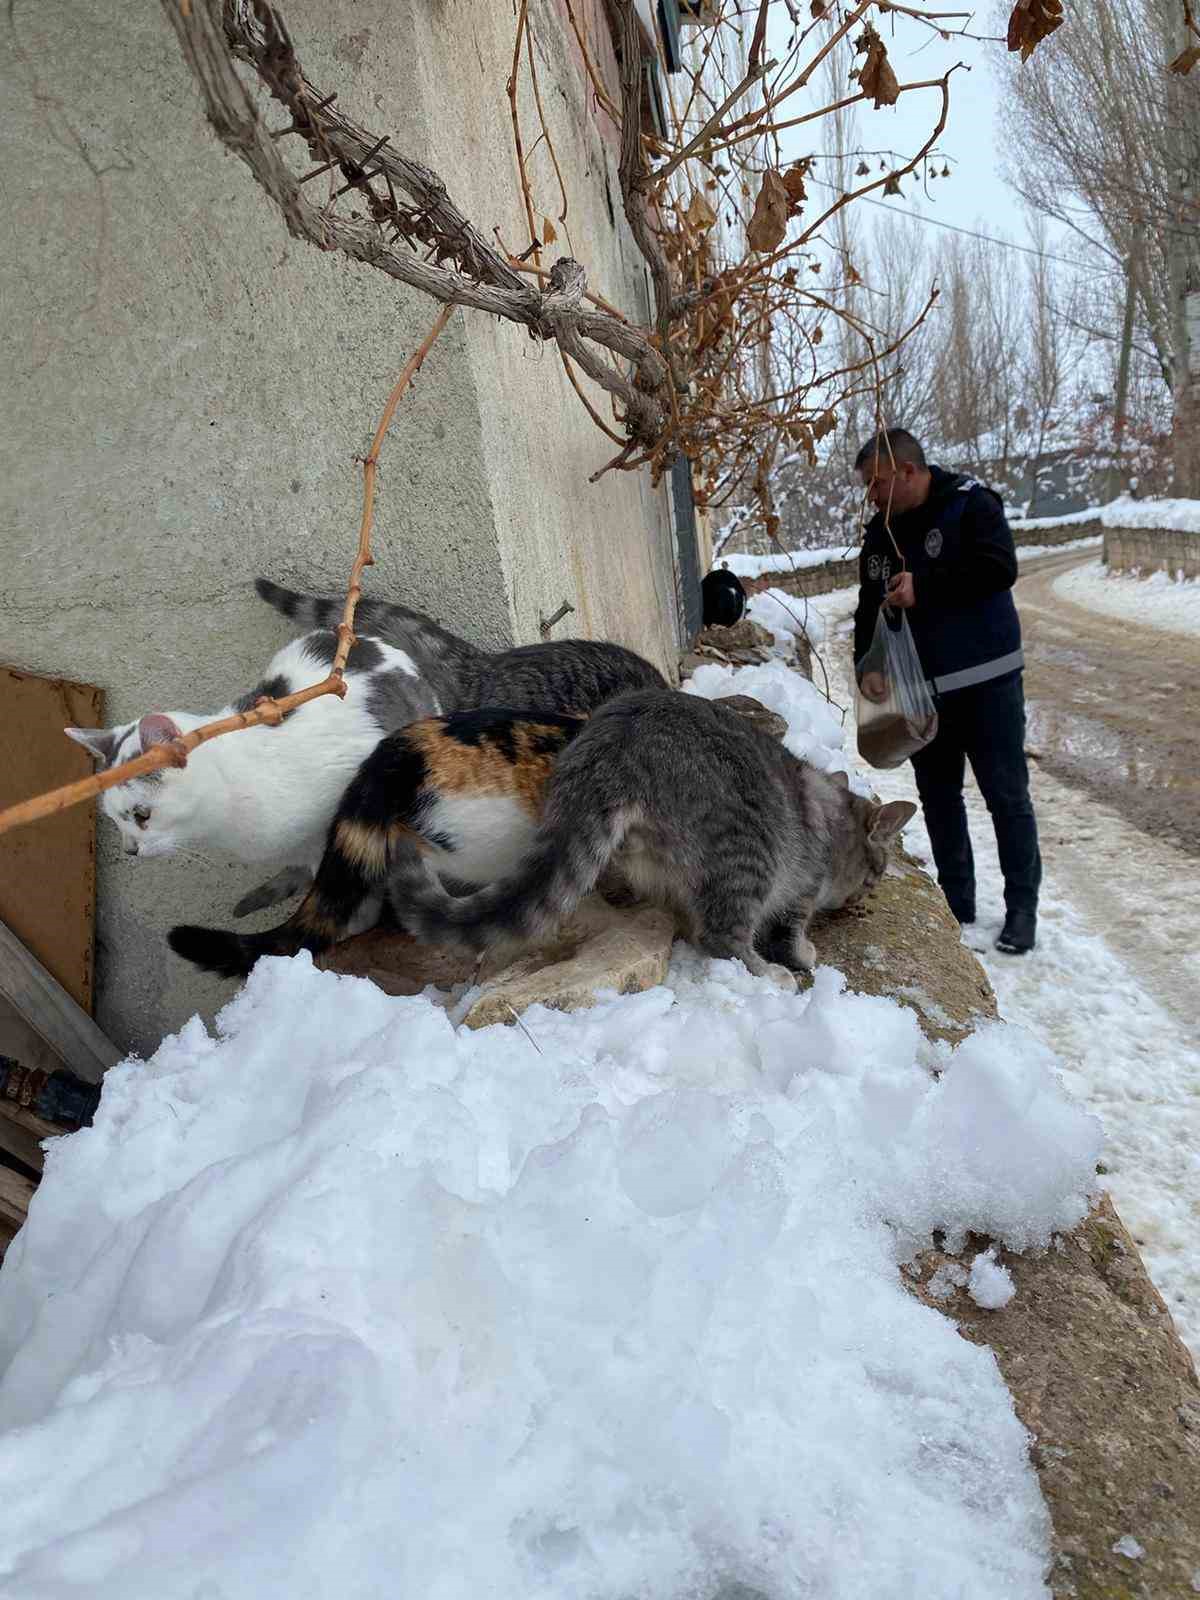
left=66, top=629, right=442, bottom=915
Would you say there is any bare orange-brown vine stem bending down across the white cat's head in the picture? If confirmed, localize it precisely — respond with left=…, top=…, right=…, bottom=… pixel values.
left=0, top=306, right=454, bottom=834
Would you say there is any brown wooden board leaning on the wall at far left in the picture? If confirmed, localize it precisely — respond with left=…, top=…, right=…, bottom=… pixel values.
left=0, top=667, right=102, bottom=1011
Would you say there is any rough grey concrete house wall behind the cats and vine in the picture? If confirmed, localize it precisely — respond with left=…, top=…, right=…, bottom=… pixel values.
left=0, top=0, right=677, bottom=1050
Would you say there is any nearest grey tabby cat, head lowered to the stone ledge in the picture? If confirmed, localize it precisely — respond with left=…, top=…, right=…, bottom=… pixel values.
left=390, top=690, right=917, bottom=986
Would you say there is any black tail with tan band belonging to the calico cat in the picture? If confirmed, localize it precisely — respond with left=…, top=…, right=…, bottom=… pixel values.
left=166, top=728, right=424, bottom=978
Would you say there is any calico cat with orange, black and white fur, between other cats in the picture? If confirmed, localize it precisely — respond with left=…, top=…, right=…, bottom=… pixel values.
left=168, top=707, right=584, bottom=978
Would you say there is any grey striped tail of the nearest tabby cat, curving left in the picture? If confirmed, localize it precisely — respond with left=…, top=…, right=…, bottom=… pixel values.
left=389, top=797, right=626, bottom=950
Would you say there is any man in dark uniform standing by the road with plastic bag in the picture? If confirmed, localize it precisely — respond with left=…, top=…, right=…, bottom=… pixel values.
left=854, top=427, right=1042, bottom=955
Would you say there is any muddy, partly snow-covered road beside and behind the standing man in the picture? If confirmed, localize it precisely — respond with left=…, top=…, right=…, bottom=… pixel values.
left=800, top=582, right=1200, bottom=1355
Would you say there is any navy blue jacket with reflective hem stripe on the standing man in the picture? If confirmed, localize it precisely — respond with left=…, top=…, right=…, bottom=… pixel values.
left=854, top=467, right=1022, bottom=694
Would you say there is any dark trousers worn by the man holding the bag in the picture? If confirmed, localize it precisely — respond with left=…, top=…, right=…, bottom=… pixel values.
left=912, top=672, right=1042, bottom=922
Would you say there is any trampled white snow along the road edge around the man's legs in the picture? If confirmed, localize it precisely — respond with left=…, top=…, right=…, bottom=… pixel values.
left=814, top=579, right=1200, bottom=1358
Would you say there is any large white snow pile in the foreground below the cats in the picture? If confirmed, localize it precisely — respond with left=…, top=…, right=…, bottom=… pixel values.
left=0, top=952, right=1099, bottom=1600
